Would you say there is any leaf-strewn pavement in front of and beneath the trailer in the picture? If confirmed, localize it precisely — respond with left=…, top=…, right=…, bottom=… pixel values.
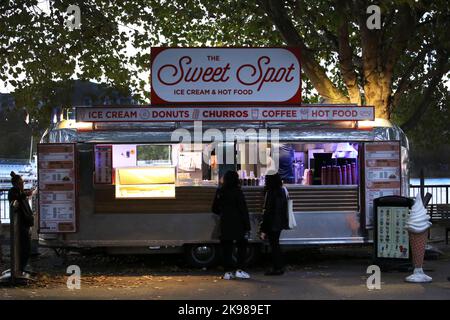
left=0, top=244, right=450, bottom=300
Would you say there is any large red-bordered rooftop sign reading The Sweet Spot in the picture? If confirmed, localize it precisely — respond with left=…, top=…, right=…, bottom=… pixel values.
left=151, top=47, right=301, bottom=104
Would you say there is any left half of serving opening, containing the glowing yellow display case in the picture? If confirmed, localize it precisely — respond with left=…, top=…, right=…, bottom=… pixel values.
left=94, top=143, right=218, bottom=199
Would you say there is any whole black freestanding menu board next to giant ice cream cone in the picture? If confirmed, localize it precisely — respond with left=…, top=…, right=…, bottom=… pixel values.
left=373, top=196, right=414, bottom=271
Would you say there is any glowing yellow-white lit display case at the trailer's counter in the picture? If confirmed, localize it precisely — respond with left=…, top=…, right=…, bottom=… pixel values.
left=116, top=166, right=175, bottom=199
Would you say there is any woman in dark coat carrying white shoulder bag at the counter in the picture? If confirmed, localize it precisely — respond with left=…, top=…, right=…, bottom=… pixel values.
left=260, top=173, right=289, bottom=275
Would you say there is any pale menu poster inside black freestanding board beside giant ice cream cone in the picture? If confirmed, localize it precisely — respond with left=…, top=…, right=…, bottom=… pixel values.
left=377, top=207, right=409, bottom=259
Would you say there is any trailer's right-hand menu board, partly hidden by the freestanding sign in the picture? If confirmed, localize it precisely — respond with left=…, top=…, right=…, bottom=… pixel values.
left=364, top=141, right=401, bottom=228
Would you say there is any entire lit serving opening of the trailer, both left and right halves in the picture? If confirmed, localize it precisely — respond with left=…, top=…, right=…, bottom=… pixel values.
left=94, top=142, right=360, bottom=199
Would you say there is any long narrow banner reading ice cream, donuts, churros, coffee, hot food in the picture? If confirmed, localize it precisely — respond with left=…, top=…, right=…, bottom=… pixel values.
left=76, top=105, right=375, bottom=122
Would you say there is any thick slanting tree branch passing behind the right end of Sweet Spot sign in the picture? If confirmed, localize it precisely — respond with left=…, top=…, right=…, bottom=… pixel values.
left=258, top=0, right=349, bottom=103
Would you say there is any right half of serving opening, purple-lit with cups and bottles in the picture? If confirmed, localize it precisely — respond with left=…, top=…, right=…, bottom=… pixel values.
left=236, top=142, right=360, bottom=186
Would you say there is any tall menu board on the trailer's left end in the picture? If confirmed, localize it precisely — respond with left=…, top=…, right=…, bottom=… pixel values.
left=38, top=143, right=77, bottom=233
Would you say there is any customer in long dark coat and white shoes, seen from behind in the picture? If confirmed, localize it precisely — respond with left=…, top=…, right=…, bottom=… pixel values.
left=212, top=171, right=250, bottom=280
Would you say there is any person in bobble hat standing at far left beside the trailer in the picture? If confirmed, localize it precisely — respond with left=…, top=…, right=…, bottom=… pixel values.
left=8, top=171, right=34, bottom=272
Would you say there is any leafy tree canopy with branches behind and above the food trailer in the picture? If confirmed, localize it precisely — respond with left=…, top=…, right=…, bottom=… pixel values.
left=0, top=0, right=450, bottom=138
